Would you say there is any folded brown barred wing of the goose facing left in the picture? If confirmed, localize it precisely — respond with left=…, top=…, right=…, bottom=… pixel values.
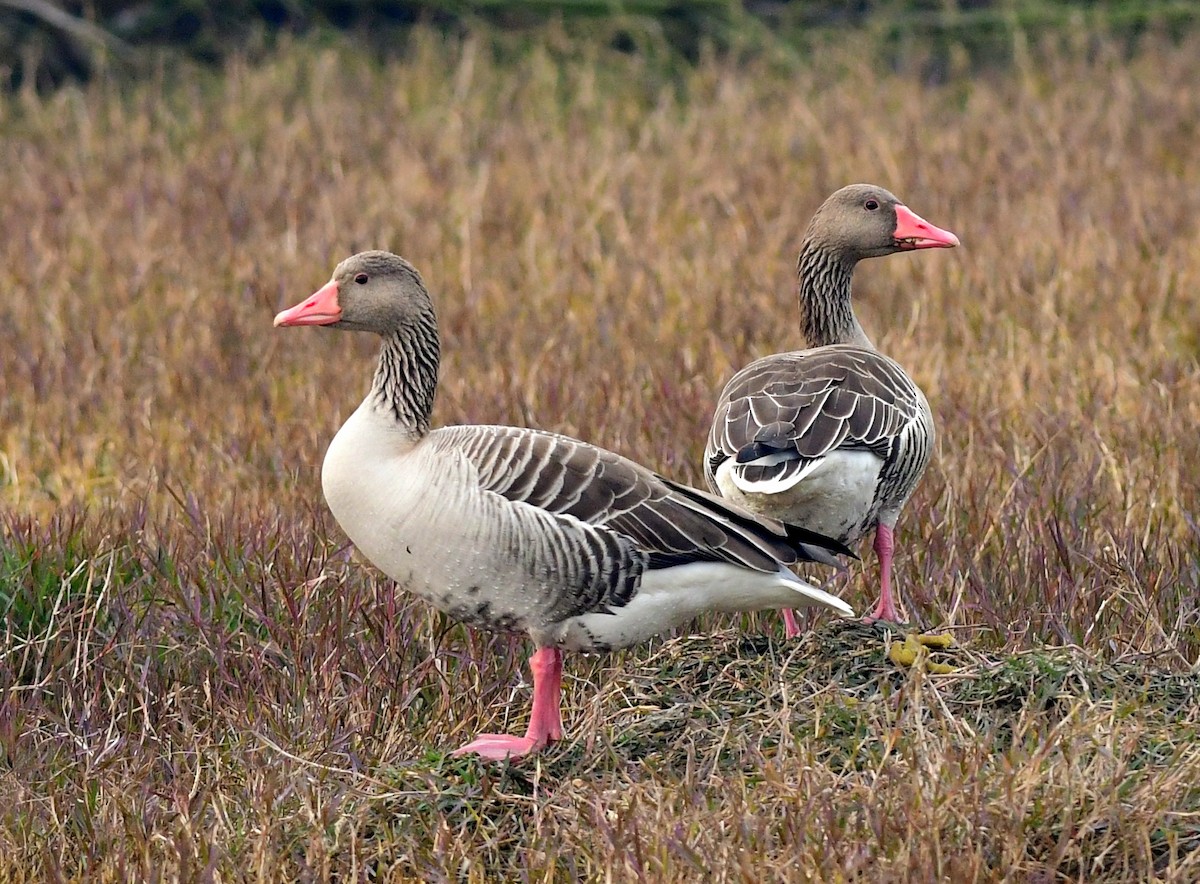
left=433, top=426, right=852, bottom=613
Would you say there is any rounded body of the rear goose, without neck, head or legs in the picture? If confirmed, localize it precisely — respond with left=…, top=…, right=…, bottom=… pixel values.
left=704, top=344, right=935, bottom=543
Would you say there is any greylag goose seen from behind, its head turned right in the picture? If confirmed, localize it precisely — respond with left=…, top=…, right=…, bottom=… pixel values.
left=704, top=185, right=959, bottom=637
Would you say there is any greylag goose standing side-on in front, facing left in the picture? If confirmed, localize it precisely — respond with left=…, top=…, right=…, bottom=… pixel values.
left=275, top=252, right=852, bottom=759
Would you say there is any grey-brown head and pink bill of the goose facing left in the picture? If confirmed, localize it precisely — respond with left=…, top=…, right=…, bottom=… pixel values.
left=275, top=251, right=433, bottom=336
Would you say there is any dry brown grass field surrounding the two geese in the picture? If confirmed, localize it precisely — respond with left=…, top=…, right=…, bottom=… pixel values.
left=0, top=24, right=1200, bottom=882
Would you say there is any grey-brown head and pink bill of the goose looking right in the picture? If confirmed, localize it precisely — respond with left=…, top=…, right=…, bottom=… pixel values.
left=806, top=185, right=959, bottom=264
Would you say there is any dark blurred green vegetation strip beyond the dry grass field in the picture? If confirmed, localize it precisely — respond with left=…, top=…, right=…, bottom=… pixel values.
left=7, top=0, right=1200, bottom=88
